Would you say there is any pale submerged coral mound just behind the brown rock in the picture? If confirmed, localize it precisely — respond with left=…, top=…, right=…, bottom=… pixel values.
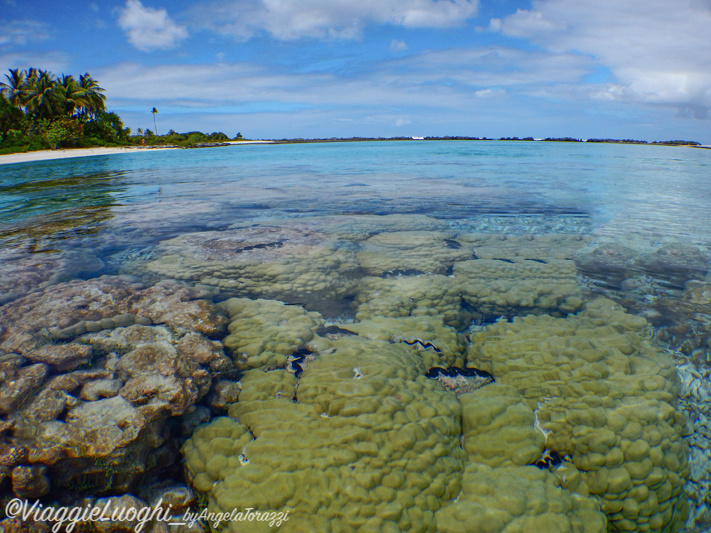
left=146, top=227, right=358, bottom=310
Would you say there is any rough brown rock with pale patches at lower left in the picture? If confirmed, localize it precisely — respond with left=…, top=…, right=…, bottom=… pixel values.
left=0, top=277, right=234, bottom=497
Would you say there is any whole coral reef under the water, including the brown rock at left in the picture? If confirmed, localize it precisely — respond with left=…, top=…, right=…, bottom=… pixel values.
left=0, top=210, right=700, bottom=533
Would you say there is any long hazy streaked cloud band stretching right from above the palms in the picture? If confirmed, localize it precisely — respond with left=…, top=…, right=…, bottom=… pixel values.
left=96, top=48, right=590, bottom=118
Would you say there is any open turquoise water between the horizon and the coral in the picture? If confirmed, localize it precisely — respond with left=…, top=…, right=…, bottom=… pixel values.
left=0, top=141, right=711, bottom=242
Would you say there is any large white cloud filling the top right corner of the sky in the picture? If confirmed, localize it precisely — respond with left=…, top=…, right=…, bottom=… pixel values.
left=490, top=0, right=711, bottom=117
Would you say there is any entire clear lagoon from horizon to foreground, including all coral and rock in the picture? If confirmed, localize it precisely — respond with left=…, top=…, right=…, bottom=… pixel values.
left=0, top=141, right=711, bottom=533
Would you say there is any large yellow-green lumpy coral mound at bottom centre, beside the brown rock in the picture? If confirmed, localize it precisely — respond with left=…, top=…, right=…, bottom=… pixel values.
left=184, top=337, right=465, bottom=531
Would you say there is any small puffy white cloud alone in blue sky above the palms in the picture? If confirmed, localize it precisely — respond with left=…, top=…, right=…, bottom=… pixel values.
left=119, top=0, right=188, bottom=52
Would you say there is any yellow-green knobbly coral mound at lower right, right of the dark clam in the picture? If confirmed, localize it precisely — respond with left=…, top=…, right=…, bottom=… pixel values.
left=469, top=298, right=689, bottom=531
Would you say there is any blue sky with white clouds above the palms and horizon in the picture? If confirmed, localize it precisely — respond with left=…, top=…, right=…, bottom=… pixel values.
left=0, top=0, right=711, bottom=144
